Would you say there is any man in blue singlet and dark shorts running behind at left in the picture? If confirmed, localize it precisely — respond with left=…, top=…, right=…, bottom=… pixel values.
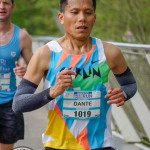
left=0, top=0, right=32, bottom=150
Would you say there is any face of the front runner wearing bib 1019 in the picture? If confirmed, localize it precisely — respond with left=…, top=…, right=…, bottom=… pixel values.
left=58, top=0, right=96, bottom=40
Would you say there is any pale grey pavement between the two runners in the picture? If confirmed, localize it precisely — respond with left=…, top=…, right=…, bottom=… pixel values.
left=14, top=107, right=47, bottom=150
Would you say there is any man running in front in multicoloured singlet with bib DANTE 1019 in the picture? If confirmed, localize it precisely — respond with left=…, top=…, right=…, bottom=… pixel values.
left=13, top=0, right=137, bottom=150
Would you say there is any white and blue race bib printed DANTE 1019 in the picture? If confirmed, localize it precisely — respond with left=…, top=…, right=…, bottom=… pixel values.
left=63, top=91, right=100, bottom=119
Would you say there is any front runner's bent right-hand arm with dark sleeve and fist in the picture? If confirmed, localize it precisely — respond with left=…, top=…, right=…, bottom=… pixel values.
left=104, top=43, right=137, bottom=106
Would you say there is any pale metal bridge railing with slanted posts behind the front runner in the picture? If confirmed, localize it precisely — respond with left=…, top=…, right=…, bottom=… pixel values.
left=33, top=36, right=150, bottom=146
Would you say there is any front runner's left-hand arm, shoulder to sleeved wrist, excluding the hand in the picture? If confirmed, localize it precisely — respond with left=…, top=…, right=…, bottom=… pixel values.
left=12, top=46, right=50, bottom=112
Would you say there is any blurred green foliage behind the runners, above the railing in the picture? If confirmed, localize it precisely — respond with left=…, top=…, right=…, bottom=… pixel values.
left=12, top=0, right=150, bottom=44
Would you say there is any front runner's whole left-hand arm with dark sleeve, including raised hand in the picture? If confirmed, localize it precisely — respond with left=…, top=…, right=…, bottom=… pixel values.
left=13, top=46, right=75, bottom=112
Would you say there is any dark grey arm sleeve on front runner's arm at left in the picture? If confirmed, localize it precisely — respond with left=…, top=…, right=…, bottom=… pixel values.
left=12, top=79, right=53, bottom=113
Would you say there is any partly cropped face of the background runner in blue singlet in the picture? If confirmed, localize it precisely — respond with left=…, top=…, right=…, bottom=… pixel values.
left=0, top=0, right=14, bottom=22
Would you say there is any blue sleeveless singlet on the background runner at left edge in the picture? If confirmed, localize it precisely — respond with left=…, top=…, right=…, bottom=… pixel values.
left=0, top=25, right=20, bottom=104
